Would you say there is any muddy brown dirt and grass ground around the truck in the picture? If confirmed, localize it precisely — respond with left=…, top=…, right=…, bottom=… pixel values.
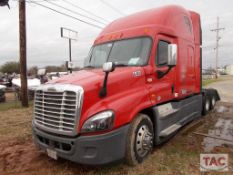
left=0, top=102, right=233, bottom=175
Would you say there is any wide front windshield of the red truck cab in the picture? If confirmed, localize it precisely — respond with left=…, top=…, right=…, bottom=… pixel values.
left=86, top=37, right=151, bottom=68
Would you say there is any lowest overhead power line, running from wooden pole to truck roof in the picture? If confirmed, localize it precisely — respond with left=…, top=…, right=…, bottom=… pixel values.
left=26, top=1, right=103, bottom=29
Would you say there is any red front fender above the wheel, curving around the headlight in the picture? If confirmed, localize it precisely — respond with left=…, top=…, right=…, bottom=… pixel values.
left=79, top=86, right=152, bottom=131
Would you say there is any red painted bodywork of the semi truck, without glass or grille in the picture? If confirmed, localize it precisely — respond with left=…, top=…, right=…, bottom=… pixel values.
left=50, top=6, right=201, bottom=134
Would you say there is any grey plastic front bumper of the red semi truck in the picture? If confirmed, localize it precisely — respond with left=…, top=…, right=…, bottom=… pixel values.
left=33, top=125, right=129, bottom=165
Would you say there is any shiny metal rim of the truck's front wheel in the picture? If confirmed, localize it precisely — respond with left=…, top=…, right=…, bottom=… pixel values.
left=136, top=125, right=153, bottom=157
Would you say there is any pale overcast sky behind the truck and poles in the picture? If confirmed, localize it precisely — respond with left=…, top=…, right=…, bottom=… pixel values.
left=0, top=0, right=233, bottom=67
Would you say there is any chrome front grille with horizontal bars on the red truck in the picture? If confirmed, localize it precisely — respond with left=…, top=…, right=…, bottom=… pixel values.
left=34, top=85, right=83, bottom=135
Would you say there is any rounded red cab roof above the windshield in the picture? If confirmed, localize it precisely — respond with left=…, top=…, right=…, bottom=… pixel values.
left=95, top=5, right=199, bottom=44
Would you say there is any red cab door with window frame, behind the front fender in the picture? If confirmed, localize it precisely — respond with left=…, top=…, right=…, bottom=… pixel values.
left=147, top=35, right=175, bottom=104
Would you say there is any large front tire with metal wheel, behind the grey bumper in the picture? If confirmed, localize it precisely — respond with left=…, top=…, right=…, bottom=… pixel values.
left=125, top=114, right=154, bottom=166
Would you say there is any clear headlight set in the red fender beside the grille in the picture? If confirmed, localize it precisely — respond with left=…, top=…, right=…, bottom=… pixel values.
left=81, top=111, right=114, bottom=133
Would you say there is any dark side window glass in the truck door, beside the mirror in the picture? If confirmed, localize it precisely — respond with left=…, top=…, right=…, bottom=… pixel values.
left=155, top=41, right=169, bottom=66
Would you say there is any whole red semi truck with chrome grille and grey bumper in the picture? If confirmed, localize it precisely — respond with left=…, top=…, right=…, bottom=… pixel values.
left=32, top=6, right=220, bottom=165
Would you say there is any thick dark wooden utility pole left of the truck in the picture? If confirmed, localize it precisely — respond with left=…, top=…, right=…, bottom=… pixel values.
left=19, top=0, right=28, bottom=107
